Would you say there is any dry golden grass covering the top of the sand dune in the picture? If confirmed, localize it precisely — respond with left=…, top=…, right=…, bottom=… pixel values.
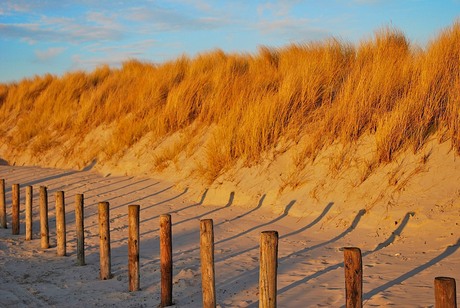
left=0, top=22, right=460, bottom=186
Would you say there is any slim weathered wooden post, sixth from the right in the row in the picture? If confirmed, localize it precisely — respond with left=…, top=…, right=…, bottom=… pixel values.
left=128, top=204, right=140, bottom=292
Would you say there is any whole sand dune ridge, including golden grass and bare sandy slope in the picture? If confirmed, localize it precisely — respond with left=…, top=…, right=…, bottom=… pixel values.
left=0, top=21, right=460, bottom=224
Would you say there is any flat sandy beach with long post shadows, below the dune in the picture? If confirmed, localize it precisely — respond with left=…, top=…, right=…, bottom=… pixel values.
left=0, top=166, right=460, bottom=307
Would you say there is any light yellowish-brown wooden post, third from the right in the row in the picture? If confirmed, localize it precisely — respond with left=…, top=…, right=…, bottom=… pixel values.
left=259, top=231, right=278, bottom=308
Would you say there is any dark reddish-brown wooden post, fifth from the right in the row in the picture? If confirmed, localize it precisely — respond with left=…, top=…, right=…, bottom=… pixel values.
left=160, top=214, right=173, bottom=307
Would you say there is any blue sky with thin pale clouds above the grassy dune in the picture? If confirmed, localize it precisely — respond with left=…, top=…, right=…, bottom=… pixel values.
left=0, top=0, right=460, bottom=82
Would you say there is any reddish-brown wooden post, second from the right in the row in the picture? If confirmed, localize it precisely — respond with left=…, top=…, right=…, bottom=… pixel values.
left=343, top=247, right=363, bottom=308
